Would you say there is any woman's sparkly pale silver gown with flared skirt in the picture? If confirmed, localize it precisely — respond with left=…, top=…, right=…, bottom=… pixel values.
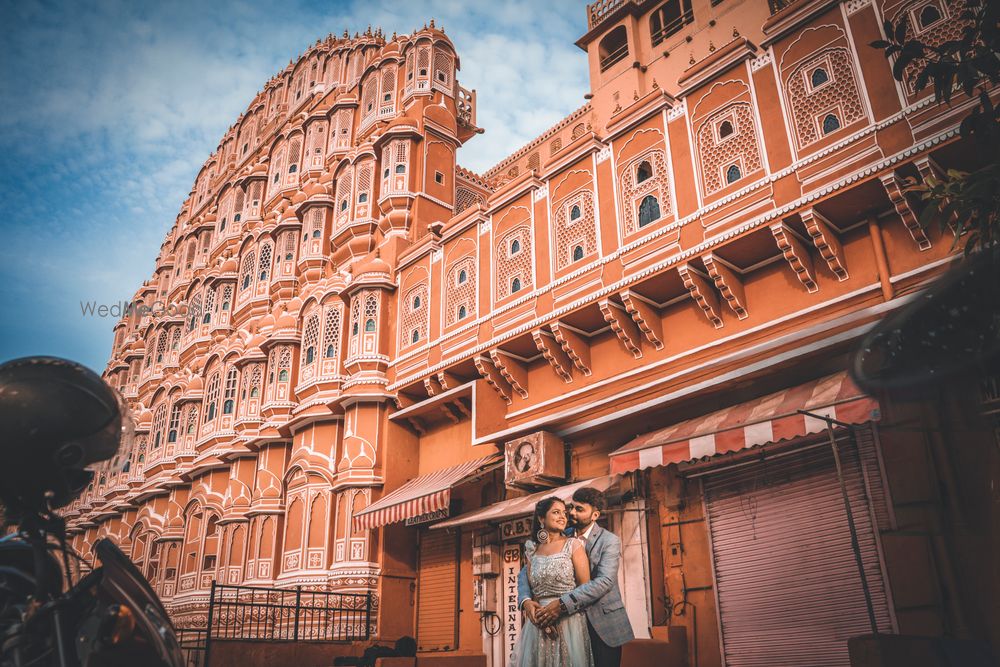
left=511, top=537, right=594, bottom=667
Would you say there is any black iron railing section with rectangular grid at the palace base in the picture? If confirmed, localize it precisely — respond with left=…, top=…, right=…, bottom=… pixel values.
left=208, top=582, right=372, bottom=643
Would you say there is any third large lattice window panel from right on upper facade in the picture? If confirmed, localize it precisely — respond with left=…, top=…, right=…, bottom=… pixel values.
left=698, top=102, right=761, bottom=195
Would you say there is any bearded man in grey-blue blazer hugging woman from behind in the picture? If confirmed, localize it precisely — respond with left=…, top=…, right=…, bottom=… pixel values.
left=517, top=487, right=635, bottom=667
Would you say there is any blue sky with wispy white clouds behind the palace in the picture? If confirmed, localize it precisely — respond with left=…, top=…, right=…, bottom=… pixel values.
left=0, top=0, right=588, bottom=371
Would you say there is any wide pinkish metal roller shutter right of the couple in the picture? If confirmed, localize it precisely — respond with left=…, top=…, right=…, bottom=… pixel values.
left=704, top=430, right=893, bottom=667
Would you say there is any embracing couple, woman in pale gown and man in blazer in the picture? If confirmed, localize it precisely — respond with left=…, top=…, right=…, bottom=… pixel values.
left=512, top=487, right=634, bottom=667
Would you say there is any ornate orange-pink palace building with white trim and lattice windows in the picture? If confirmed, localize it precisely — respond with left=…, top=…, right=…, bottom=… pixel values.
left=68, top=0, right=1000, bottom=667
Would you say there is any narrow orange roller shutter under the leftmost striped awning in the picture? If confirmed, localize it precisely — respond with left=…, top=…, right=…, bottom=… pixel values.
left=417, top=530, right=459, bottom=651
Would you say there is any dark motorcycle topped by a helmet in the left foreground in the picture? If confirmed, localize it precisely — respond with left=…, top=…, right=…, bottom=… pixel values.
left=0, top=357, right=185, bottom=667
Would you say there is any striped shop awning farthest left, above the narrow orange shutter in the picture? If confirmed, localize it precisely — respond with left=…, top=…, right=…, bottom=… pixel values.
left=354, top=453, right=503, bottom=530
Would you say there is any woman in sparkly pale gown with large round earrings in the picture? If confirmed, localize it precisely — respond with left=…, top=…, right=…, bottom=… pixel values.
left=511, top=496, right=594, bottom=667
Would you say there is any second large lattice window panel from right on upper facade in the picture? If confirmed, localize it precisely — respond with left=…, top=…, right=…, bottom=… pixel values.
left=787, top=48, right=865, bottom=147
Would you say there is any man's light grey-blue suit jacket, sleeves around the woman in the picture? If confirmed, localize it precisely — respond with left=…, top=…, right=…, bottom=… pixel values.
left=517, top=526, right=635, bottom=664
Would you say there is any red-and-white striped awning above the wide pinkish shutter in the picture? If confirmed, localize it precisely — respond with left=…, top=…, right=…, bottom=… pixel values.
left=611, top=371, right=879, bottom=473
